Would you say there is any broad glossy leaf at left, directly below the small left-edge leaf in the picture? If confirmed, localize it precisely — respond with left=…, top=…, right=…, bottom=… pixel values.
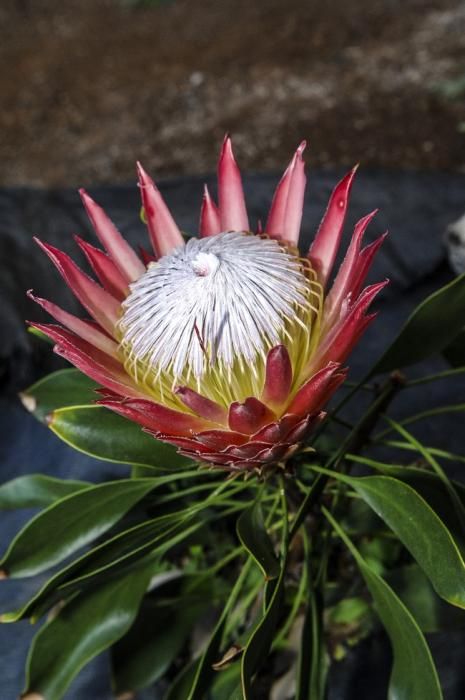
left=0, top=479, right=169, bottom=577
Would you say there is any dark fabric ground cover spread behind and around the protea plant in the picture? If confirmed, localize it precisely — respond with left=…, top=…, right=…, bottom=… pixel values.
left=0, top=171, right=465, bottom=700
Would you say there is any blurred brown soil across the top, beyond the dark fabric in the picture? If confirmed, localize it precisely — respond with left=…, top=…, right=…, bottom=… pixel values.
left=0, top=0, right=465, bottom=186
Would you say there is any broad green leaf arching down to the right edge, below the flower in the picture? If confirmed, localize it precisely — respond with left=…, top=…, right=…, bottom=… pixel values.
left=318, top=472, right=465, bottom=608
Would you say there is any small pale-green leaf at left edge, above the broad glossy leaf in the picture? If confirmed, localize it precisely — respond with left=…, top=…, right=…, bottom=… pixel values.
left=0, top=474, right=91, bottom=510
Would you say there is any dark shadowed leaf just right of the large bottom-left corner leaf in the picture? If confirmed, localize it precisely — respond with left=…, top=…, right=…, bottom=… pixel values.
left=112, top=572, right=214, bottom=695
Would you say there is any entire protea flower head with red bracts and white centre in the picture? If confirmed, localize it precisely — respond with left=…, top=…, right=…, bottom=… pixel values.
left=30, top=138, right=386, bottom=471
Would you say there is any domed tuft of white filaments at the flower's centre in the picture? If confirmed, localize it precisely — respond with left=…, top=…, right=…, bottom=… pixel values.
left=120, top=232, right=308, bottom=382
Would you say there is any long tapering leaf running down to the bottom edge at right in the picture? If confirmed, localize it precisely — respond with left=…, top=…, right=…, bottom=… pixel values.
left=323, top=507, right=442, bottom=700
